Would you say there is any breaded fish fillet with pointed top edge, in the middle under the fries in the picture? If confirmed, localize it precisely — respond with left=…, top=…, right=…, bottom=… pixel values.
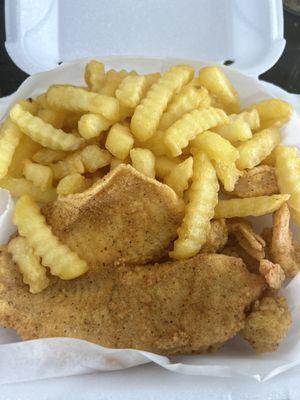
left=43, top=164, right=184, bottom=268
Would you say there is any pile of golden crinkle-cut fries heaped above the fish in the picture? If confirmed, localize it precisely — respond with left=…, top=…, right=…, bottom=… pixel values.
left=0, top=60, right=300, bottom=292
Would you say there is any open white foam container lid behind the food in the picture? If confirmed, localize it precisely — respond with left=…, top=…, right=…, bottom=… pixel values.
left=5, top=0, right=285, bottom=76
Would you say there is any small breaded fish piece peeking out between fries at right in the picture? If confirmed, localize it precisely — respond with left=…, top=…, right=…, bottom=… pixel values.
left=232, top=165, right=279, bottom=198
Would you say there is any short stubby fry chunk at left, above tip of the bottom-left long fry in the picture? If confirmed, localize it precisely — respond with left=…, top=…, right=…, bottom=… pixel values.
left=23, top=160, right=53, bottom=192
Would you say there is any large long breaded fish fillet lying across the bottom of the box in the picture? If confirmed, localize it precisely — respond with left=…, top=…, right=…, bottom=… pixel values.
left=0, top=249, right=265, bottom=355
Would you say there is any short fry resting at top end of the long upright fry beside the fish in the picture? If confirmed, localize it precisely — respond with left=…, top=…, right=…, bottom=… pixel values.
left=190, top=131, right=239, bottom=163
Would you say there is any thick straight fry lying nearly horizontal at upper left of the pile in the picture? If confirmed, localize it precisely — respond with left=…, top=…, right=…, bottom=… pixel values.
left=47, top=85, right=119, bottom=121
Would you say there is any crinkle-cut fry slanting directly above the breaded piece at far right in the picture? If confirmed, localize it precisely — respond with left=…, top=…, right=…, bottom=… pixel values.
left=236, top=128, right=280, bottom=170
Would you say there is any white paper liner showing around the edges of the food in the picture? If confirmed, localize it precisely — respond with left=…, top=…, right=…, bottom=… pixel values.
left=0, top=57, right=300, bottom=384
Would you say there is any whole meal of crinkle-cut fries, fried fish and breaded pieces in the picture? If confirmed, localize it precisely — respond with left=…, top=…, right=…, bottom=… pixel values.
left=0, top=60, right=300, bottom=355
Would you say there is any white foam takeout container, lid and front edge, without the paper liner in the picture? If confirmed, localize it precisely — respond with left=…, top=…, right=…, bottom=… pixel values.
left=0, top=0, right=300, bottom=400
